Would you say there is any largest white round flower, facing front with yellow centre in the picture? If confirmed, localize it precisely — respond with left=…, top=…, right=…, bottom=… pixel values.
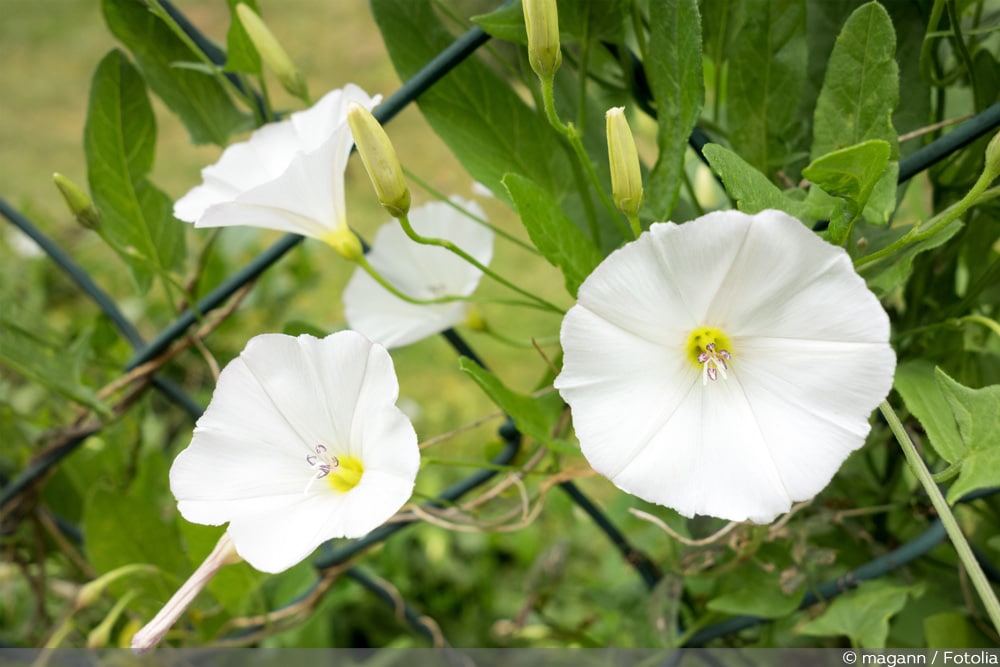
left=555, top=211, right=895, bottom=522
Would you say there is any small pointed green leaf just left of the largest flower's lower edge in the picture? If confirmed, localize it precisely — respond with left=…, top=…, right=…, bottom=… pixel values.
left=458, top=357, right=579, bottom=454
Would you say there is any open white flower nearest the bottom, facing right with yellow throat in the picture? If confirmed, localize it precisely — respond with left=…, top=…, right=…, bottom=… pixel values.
left=170, top=331, right=420, bottom=572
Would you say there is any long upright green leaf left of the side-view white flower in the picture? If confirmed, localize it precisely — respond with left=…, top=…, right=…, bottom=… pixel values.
left=84, top=50, right=184, bottom=291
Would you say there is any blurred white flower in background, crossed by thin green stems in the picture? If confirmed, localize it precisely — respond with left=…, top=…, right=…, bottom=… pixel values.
left=344, top=197, right=493, bottom=347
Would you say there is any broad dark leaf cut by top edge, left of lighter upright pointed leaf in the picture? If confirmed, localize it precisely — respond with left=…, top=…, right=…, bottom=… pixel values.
left=726, top=0, right=807, bottom=178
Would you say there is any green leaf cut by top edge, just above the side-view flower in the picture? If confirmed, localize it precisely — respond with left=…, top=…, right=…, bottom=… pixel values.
left=102, top=0, right=250, bottom=146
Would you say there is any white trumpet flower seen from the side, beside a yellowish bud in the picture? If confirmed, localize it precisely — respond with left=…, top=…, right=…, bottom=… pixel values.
left=174, top=84, right=381, bottom=240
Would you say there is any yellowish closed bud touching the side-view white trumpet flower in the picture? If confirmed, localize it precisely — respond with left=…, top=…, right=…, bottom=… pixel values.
left=347, top=102, right=410, bottom=218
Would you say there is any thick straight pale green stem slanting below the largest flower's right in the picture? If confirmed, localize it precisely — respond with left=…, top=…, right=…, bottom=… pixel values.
left=879, top=401, right=1000, bottom=632
